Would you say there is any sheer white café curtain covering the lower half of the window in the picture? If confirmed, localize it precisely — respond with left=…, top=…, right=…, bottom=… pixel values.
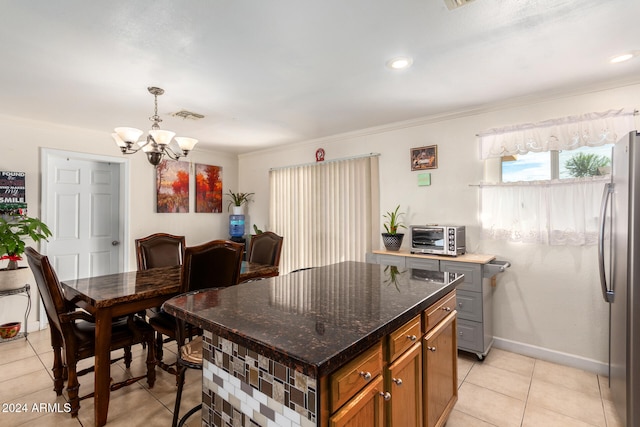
left=481, top=177, right=609, bottom=245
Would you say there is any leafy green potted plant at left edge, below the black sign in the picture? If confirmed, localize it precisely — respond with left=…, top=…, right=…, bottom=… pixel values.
left=0, top=215, right=51, bottom=270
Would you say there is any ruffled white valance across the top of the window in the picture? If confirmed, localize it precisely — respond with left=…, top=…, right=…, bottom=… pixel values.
left=478, top=109, right=635, bottom=160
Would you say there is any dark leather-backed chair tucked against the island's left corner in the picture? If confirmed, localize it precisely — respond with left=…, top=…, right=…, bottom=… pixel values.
left=172, top=240, right=244, bottom=427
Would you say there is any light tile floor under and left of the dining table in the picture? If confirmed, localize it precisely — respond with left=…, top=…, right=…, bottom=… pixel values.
left=0, top=330, right=202, bottom=427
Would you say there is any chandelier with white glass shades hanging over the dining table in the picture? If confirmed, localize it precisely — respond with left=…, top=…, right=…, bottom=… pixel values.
left=111, top=87, right=198, bottom=166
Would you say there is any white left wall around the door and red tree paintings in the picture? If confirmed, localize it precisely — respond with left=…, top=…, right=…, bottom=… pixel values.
left=0, top=115, right=238, bottom=330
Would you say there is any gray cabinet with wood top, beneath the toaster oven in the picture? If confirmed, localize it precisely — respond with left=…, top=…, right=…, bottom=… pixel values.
left=367, top=252, right=498, bottom=360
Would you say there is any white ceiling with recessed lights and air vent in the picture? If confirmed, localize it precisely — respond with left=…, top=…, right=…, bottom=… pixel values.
left=0, top=0, right=640, bottom=153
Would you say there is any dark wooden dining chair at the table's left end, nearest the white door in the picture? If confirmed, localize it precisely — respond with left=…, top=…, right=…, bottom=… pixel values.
left=25, top=247, right=156, bottom=417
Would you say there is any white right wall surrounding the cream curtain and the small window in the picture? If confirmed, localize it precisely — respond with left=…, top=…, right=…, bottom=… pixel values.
left=239, top=85, right=640, bottom=371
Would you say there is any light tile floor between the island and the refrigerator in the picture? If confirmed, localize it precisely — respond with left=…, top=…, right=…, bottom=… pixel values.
left=446, top=348, right=623, bottom=427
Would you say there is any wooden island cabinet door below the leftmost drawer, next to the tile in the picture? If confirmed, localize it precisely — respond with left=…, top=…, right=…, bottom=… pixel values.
left=329, top=375, right=384, bottom=427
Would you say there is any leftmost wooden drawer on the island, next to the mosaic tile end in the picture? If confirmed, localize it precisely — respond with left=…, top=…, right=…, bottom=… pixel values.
left=329, top=343, right=382, bottom=413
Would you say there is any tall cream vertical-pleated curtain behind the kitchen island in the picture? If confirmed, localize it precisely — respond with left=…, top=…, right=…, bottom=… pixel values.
left=269, top=155, right=380, bottom=272
